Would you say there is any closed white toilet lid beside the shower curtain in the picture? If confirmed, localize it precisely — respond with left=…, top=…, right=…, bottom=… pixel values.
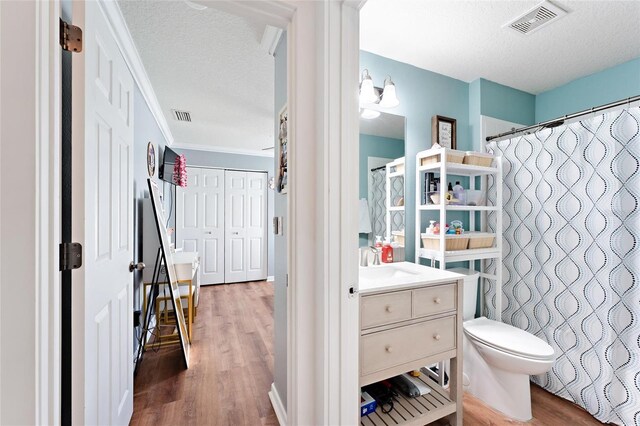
left=464, top=317, right=554, bottom=359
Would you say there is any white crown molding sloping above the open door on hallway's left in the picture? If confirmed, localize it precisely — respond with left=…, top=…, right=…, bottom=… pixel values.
left=99, top=0, right=174, bottom=146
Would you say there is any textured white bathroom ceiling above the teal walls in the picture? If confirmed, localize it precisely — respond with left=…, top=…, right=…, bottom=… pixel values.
left=360, top=0, right=640, bottom=94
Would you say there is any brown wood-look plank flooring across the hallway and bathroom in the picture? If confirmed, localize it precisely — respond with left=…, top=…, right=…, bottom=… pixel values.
left=131, top=282, right=602, bottom=426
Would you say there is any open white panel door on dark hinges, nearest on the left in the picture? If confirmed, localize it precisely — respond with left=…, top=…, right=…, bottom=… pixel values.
left=72, top=1, right=134, bottom=425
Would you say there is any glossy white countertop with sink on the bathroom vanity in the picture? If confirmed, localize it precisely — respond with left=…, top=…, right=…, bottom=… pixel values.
left=359, top=262, right=464, bottom=295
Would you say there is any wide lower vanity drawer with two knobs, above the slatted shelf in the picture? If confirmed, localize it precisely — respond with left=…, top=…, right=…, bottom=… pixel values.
left=360, top=315, right=456, bottom=376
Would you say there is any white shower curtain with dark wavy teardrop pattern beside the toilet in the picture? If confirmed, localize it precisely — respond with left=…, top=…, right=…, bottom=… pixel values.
left=485, top=107, right=640, bottom=425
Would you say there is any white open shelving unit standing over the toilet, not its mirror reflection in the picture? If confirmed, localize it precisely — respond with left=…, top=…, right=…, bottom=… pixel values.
left=415, top=149, right=502, bottom=321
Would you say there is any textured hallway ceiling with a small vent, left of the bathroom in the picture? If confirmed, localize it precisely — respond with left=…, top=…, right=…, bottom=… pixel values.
left=119, top=0, right=275, bottom=150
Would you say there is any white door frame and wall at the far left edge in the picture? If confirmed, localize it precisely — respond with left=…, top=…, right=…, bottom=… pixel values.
left=0, top=0, right=61, bottom=424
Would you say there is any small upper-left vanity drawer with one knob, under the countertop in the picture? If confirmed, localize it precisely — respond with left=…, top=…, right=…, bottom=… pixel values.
left=360, top=290, right=411, bottom=329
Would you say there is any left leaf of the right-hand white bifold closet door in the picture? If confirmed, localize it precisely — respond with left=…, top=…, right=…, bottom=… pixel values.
left=224, top=170, right=247, bottom=283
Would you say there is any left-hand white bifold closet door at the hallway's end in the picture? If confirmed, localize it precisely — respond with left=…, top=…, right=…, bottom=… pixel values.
left=176, top=167, right=224, bottom=284
